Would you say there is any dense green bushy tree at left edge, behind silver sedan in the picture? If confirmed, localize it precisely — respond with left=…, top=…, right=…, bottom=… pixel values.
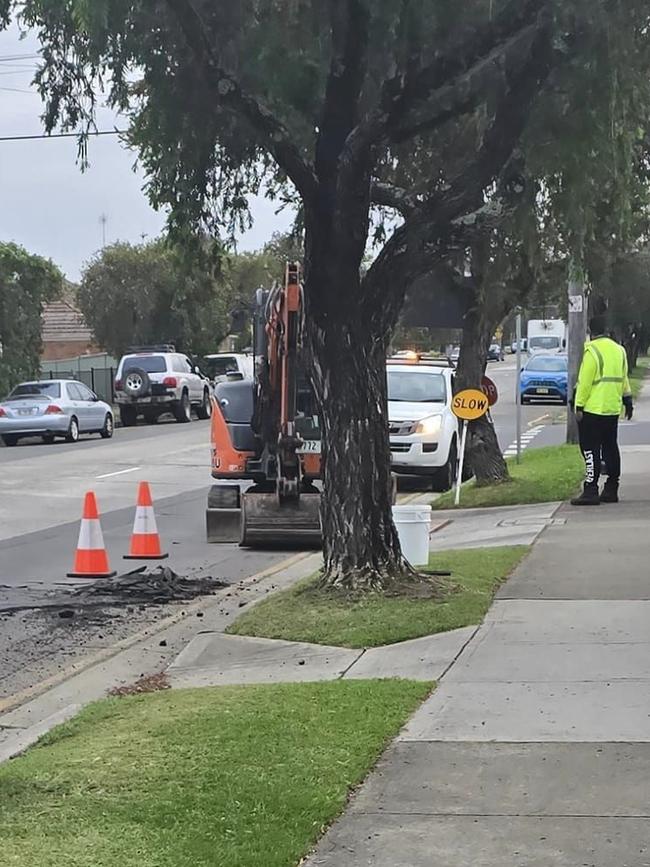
left=0, top=243, right=63, bottom=396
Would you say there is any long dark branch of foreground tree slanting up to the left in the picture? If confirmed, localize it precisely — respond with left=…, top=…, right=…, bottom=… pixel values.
left=166, top=0, right=318, bottom=201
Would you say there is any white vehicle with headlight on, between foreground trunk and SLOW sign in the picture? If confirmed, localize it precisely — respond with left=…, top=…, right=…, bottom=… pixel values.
left=386, top=358, right=458, bottom=491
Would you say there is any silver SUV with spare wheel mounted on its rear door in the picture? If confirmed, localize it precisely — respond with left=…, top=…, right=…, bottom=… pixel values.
left=115, top=346, right=212, bottom=427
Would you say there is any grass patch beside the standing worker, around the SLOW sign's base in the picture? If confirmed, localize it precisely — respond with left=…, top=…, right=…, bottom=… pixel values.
left=431, top=445, right=584, bottom=509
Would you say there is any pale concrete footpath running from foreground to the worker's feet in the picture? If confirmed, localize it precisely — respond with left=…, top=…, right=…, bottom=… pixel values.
left=305, top=446, right=650, bottom=867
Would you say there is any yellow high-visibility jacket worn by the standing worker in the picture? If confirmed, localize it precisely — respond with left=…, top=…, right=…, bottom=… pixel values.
left=576, top=337, right=632, bottom=415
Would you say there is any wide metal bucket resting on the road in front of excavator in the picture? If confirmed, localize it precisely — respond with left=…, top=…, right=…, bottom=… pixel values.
left=239, top=493, right=322, bottom=548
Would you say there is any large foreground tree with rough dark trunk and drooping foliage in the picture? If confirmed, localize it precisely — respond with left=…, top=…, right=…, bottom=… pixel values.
left=16, top=0, right=647, bottom=587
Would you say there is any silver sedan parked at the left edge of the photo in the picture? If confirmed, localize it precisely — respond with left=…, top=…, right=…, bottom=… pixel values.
left=0, top=379, right=114, bottom=446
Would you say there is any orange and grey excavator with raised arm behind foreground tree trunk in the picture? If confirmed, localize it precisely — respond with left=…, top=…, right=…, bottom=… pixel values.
left=206, top=265, right=321, bottom=547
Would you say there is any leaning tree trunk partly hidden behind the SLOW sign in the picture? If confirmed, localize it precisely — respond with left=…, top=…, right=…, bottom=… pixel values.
left=455, top=300, right=510, bottom=485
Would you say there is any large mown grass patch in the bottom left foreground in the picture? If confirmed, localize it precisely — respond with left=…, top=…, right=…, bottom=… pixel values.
left=0, top=680, right=431, bottom=867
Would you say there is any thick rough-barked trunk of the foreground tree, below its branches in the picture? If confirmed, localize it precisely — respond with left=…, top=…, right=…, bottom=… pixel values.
left=305, top=204, right=415, bottom=593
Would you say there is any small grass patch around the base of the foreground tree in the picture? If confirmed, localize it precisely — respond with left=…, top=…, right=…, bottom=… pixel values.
left=228, top=546, right=528, bottom=647
